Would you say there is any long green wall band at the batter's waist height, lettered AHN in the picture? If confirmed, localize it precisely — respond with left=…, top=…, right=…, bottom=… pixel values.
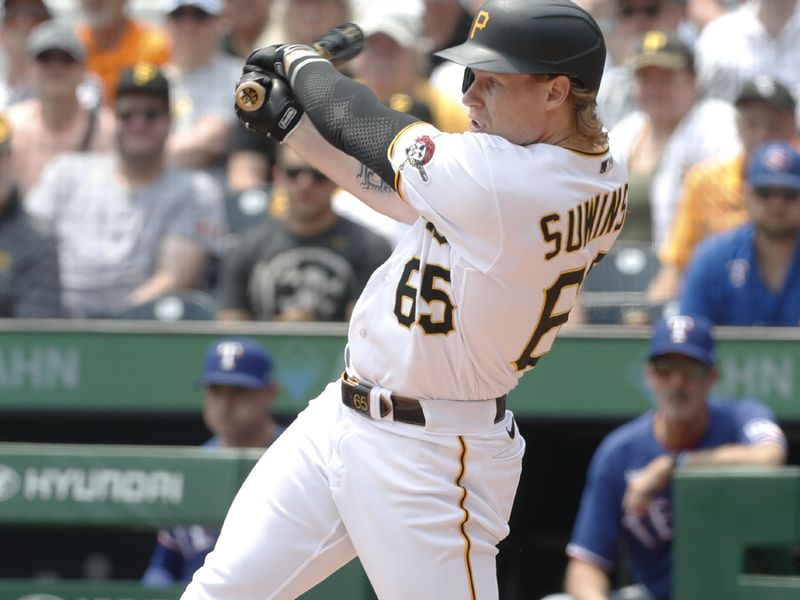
left=0, top=321, right=800, bottom=419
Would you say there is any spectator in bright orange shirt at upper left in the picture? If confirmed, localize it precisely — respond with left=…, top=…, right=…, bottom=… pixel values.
left=76, top=0, right=170, bottom=106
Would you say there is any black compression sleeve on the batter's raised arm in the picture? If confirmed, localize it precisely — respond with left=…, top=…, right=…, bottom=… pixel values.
left=289, top=60, right=419, bottom=188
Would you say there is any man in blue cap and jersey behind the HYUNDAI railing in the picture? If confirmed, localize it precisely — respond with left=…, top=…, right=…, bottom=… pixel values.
left=142, top=339, right=285, bottom=586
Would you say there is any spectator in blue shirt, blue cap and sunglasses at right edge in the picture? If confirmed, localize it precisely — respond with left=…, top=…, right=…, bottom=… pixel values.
left=680, top=141, right=800, bottom=327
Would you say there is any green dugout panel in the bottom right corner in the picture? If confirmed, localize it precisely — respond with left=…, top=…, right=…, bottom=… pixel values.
left=673, top=467, right=800, bottom=600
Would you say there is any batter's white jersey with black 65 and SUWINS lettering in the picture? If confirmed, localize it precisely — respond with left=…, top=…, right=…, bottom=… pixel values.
left=348, top=123, right=627, bottom=400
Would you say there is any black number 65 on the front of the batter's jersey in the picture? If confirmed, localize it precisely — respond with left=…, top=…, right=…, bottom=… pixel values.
left=394, top=258, right=454, bottom=334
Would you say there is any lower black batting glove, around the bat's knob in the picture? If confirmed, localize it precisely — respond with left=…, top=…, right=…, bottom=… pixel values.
left=236, top=65, right=303, bottom=142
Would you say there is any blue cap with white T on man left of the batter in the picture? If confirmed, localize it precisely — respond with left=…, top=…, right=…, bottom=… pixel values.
left=200, top=339, right=272, bottom=390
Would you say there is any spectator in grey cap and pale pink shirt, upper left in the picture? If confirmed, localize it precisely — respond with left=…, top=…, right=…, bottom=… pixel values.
left=6, top=20, right=114, bottom=200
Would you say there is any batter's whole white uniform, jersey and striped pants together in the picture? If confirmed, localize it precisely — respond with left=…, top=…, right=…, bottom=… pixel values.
left=183, top=124, right=626, bottom=600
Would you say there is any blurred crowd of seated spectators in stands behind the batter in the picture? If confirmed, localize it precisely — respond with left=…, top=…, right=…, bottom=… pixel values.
left=0, top=0, right=800, bottom=326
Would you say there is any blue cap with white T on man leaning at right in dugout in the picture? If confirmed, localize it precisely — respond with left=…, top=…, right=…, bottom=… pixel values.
left=650, top=315, right=717, bottom=365
